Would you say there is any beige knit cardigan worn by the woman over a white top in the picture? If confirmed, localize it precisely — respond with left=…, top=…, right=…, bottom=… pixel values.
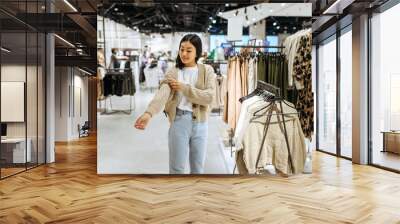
left=146, top=64, right=215, bottom=123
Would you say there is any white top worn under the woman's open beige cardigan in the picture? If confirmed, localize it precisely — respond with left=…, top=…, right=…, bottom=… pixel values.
left=178, top=66, right=199, bottom=111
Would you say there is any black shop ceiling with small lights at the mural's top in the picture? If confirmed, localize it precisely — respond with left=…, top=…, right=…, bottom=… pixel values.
left=98, top=0, right=309, bottom=34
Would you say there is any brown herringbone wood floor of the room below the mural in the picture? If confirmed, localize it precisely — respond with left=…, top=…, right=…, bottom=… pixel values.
left=0, top=134, right=400, bottom=224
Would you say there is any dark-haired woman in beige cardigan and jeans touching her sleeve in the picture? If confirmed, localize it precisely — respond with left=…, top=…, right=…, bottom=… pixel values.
left=135, top=34, right=215, bottom=174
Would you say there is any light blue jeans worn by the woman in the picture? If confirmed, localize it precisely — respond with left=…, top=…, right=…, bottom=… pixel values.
left=168, top=109, right=208, bottom=174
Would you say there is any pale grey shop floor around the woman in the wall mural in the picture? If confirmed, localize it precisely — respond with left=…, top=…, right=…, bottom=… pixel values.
left=98, top=90, right=233, bottom=174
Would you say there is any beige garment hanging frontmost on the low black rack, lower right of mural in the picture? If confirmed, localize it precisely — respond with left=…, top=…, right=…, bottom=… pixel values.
left=237, top=101, right=307, bottom=174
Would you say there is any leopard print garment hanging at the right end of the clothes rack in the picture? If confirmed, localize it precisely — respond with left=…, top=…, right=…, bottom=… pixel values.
left=293, top=33, right=314, bottom=140
